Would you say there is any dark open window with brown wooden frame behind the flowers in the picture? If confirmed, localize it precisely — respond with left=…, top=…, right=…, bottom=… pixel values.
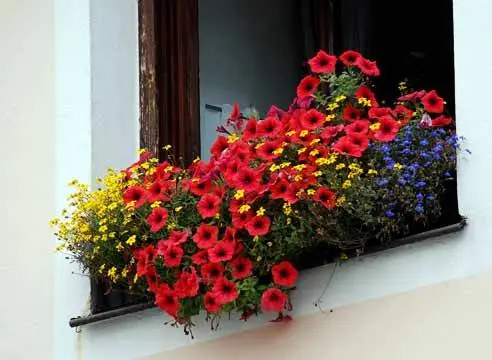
left=89, top=0, right=461, bottom=312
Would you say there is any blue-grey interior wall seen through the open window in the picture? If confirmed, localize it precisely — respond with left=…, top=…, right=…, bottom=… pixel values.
left=199, top=0, right=304, bottom=157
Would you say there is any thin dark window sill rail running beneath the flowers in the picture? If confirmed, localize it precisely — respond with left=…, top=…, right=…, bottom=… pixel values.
left=69, top=218, right=467, bottom=327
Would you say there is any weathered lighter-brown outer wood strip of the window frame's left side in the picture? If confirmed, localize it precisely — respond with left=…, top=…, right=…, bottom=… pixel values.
left=138, top=0, right=160, bottom=155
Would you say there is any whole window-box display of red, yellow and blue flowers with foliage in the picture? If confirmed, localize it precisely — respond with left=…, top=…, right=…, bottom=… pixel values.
left=55, top=51, right=459, bottom=331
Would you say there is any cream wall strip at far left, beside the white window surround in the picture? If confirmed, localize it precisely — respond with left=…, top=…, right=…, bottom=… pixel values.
left=0, top=0, right=55, bottom=360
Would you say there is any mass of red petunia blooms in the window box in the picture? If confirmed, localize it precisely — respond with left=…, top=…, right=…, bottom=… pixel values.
left=123, top=51, right=450, bottom=319
